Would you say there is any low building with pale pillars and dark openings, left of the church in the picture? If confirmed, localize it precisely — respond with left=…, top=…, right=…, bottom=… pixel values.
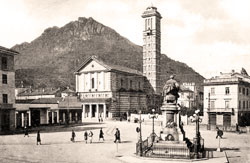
left=16, top=88, right=62, bottom=128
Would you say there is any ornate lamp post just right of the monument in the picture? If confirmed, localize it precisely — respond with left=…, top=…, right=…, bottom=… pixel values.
left=192, top=110, right=202, bottom=159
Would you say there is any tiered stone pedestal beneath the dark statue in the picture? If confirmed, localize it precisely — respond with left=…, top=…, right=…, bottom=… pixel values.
left=151, top=102, right=190, bottom=158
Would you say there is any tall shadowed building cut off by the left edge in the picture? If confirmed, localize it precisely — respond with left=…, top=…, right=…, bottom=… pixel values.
left=0, top=46, right=19, bottom=131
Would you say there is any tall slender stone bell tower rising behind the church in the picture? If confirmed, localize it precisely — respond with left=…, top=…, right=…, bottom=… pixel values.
left=142, top=6, right=162, bottom=94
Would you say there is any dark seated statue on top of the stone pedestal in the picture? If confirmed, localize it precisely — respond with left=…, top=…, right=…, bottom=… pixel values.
left=163, top=75, right=180, bottom=104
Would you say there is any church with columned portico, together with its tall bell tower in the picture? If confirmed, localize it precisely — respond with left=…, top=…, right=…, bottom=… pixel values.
left=75, top=7, right=162, bottom=120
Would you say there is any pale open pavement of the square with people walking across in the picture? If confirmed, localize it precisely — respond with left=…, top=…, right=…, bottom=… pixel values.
left=0, top=121, right=250, bottom=163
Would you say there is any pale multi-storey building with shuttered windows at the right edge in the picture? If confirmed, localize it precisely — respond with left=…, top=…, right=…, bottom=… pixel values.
left=203, top=71, right=250, bottom=130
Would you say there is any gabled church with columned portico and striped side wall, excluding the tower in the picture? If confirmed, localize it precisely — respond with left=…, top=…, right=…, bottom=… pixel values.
left=75, top=56, right=147, bottom=119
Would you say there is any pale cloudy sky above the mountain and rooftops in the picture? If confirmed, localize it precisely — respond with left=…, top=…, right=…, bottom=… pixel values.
left=0, top=0, right=250, bottom=78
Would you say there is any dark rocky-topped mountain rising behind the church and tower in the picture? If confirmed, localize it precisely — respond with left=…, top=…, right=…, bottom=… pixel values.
left=12, top=17, right=204, bottom=88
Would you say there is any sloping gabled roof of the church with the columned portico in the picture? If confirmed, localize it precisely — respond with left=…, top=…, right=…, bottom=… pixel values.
left=76, top=56, right=143, bottom=75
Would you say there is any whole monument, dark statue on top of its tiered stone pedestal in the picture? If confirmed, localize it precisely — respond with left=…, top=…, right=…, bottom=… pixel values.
left=151, top=75, right=190, bottom=158
